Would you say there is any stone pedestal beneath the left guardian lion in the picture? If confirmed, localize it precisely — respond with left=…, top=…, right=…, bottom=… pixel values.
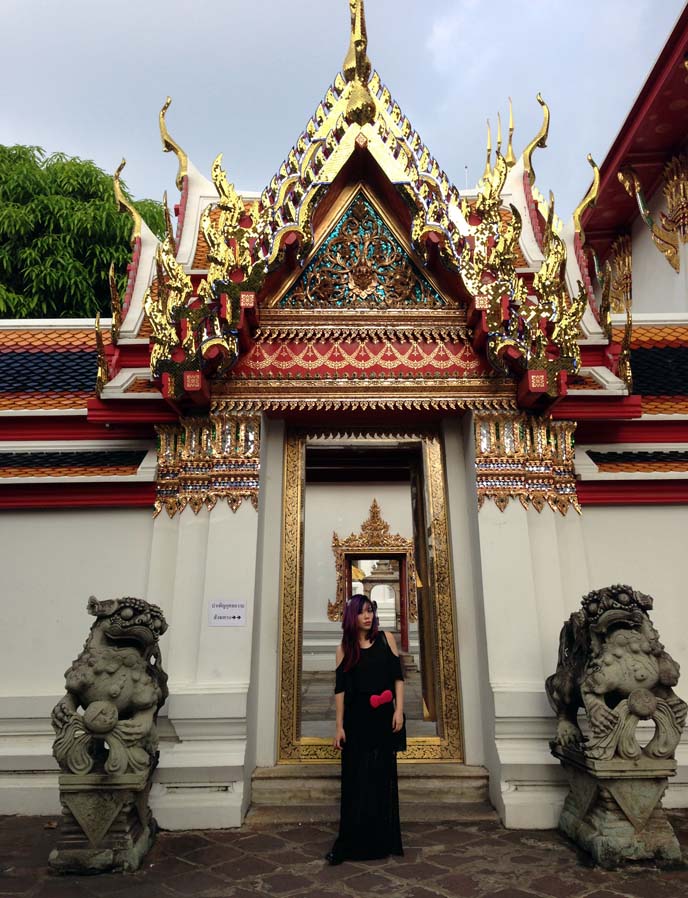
left=49, top=771, right=156, bottom=873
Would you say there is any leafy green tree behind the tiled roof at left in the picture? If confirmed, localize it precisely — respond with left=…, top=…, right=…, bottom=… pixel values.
left=0, top=146, right=165, bottom=318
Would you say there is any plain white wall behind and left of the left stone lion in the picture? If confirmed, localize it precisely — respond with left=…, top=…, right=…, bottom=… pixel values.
left=0, top=509, right=153, bottom=814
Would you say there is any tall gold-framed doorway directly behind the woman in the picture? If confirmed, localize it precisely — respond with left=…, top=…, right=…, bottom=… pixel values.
left=279, top=433, right=461, bottom=762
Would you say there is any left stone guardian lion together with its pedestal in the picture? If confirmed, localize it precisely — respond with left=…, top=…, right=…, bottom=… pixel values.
left=50, top=596, right=168, bottom=873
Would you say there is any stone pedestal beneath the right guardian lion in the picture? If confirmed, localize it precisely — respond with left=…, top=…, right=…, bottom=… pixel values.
left=552, top=744, right=681, bottom=867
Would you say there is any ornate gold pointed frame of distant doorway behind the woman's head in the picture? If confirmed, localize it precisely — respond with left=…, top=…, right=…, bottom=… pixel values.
left=327, top=499, right=418, bottom=623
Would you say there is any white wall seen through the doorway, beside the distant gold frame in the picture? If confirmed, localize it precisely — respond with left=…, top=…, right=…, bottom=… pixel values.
left=303, top=483, right=413, bottom=670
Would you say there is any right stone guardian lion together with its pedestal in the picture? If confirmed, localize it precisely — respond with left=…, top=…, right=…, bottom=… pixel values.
left=545, top=585, right=688, bottom=867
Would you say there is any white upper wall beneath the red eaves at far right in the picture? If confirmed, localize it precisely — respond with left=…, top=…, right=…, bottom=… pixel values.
left=631, top=190, right=688, bottom=314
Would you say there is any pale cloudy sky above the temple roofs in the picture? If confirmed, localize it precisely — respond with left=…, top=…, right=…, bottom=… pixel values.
left=0, top=0, right=684, bottom=216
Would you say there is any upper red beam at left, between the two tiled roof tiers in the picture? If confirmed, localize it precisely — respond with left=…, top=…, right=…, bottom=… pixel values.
left=0, top=415, right=155, bottom=441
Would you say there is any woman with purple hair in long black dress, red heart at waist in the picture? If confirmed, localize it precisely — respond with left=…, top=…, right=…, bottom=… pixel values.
left=326, top=595, right=405, bottom=864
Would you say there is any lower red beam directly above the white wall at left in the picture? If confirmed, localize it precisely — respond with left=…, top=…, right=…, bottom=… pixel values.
left=0, top=483, right=155, bottom=509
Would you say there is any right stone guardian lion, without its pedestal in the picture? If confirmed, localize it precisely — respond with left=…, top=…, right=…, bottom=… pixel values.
left=545, top=584, right=688, bottom=760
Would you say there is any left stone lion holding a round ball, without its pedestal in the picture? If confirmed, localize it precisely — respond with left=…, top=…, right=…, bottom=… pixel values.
left=52, top=596, right=168, bottom=774
